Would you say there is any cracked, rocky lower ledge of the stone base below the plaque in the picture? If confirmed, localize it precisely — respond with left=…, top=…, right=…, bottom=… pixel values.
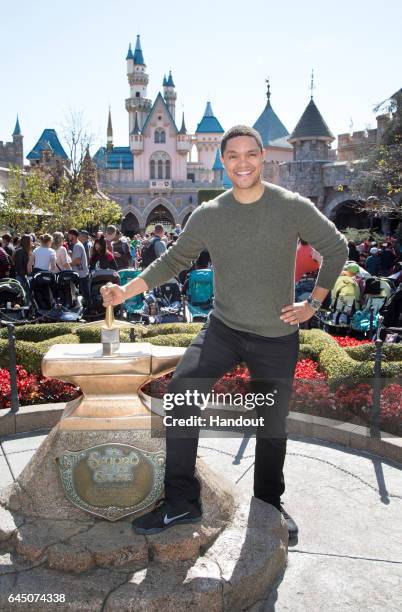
left=0, top=495, right=288, bottom=612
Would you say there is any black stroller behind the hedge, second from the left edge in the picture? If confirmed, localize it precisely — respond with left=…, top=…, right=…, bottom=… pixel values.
left=31, top=270, right=84, bottom=322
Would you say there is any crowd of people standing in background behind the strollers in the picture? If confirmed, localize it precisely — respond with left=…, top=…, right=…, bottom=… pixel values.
left=0, top=224, right=402, bottom=314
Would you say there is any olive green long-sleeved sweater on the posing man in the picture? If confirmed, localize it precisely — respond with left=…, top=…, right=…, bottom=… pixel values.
left=139, top=183, right=348, bottom=337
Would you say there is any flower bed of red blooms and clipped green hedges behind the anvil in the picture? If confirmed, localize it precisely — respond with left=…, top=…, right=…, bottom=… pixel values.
left=0, top=323, right=402, bottom=435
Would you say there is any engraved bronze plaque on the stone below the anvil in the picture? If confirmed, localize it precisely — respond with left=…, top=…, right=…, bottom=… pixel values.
left=58, top=443, right=165, bottom=521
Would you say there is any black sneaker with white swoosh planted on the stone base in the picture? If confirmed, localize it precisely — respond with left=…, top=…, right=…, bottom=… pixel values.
left=132, top=499, right=202, bottom=535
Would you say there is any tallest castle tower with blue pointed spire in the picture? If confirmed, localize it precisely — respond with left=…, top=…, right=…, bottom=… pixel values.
left=126, top=35, right=152, bottom=134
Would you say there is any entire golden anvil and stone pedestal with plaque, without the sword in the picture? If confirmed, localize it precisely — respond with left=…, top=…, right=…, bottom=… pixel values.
left=0, top=343, right=288, bottom=612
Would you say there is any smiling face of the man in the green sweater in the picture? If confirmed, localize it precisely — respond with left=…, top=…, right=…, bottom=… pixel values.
left=222, top=136, right=264, bottom=189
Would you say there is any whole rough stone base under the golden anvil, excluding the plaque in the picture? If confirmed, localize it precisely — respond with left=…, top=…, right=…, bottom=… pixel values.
left=0, top=428, right=288, bottom=612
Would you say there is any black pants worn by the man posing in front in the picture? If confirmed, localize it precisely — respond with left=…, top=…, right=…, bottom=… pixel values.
left=165, top=315, right=299, bottom=509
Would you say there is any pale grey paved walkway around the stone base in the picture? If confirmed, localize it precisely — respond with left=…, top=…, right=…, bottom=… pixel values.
left=0, top=432, right=402, bottom=612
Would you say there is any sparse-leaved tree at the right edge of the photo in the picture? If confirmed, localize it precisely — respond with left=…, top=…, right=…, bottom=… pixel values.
left=351, top=90, right=402, bottom=218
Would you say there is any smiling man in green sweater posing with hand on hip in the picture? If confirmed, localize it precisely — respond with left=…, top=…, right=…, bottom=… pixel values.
left=102, top=126, right=348, bottom=537
